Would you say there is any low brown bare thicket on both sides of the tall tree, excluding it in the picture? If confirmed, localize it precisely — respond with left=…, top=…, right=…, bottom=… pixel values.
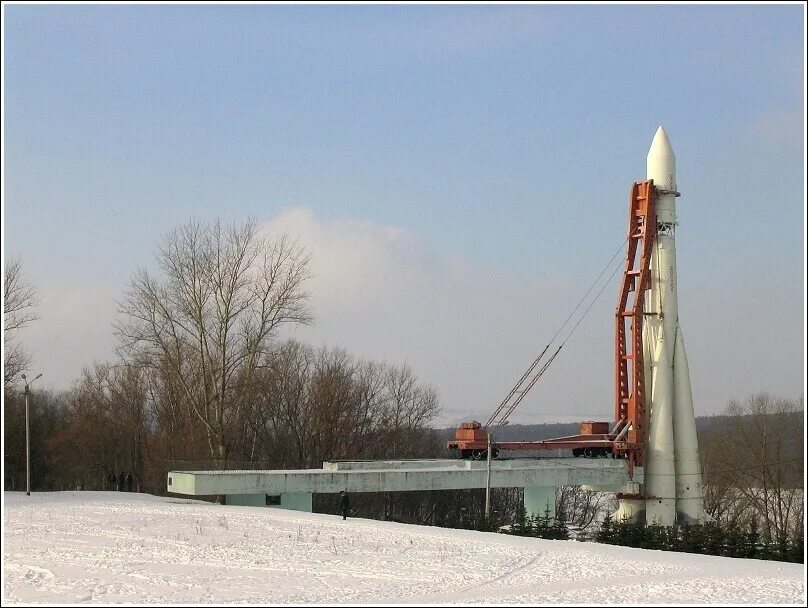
left=4, top=341, right=439, bottom=494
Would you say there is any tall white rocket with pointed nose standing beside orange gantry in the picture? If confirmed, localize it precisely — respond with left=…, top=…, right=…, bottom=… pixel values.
left=638, top=127, right=705, bottom=526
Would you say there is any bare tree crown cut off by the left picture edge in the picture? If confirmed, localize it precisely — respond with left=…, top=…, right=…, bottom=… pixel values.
left=3, top=258, right=39, bottom=388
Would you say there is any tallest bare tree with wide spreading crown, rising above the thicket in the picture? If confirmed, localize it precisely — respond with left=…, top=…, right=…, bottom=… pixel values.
left=116, top=221, right=312, bottom=476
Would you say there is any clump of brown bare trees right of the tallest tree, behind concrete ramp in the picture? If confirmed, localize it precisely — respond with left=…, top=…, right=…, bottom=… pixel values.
left=242, top=340, right=438, bottom=467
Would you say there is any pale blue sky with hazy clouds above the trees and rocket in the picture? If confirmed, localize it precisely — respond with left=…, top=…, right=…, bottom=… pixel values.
left=3, top=4, right=805, bottom=424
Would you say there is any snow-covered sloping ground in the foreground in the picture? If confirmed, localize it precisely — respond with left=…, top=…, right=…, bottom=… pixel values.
left=3, top=492, right=806, bottom=605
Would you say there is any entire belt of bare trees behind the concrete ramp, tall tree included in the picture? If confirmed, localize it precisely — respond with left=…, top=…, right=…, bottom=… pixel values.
left=4, top=221, right=439, bottom=494
